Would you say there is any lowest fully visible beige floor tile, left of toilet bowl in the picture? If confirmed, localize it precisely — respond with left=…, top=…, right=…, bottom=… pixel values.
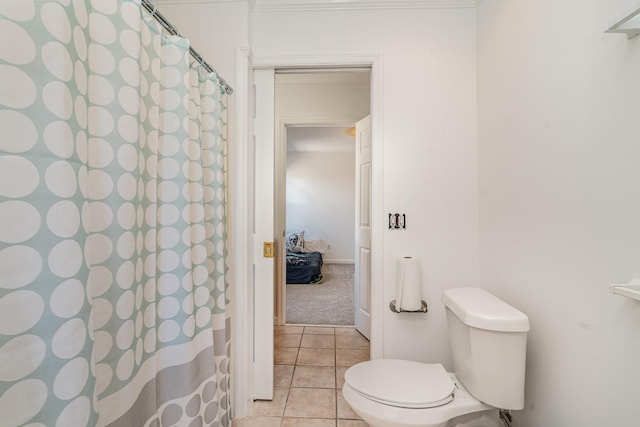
left=284, top=388, right=336, bottom=419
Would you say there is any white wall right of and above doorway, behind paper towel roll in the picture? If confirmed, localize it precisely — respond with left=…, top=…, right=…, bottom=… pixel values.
left=251, top=9, right=479, bottom=366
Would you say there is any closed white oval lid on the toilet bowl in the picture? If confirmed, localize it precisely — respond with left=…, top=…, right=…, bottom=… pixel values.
left=344, top=359, right=455, bottom=408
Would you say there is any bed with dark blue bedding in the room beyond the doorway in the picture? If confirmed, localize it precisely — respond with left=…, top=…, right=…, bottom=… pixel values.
left=286, top=231, right=326, bottom=284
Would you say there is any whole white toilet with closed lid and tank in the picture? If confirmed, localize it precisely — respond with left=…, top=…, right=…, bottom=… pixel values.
left=342, top=287, right=529, bottom=427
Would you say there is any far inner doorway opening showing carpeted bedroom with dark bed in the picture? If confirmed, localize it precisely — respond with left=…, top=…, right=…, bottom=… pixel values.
left=284, top=126, right=356, bottom=326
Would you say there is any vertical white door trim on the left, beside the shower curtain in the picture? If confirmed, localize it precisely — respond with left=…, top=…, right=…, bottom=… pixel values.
left=229, top=47, right=253, bottom=418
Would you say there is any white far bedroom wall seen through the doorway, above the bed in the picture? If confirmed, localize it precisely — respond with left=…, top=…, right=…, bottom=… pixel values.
left=287, top=150, right=356, bottom=263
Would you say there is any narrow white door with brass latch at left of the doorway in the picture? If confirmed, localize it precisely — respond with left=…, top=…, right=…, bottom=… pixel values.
left=253, top=69, right=275, bottom=400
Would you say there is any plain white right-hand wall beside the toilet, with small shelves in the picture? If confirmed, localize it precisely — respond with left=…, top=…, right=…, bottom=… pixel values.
left=478, top=0, right=640, bottom=427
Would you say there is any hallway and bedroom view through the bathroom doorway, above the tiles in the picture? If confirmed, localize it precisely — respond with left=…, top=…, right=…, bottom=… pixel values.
left=275, top=68, right=370, bottom=326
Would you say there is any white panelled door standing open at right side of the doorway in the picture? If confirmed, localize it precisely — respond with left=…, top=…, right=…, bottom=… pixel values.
left=354, top=116, right=371, bottom=338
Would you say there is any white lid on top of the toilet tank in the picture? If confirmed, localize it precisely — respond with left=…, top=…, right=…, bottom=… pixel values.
left=442, top=288, right=529, bottom=332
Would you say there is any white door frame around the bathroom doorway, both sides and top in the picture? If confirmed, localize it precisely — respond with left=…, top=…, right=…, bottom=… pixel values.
left=230, top=48, right=385, bottom=418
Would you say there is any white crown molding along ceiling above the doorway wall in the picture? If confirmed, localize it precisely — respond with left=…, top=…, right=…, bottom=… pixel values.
left=253, top=0, right=479, bottom=12
